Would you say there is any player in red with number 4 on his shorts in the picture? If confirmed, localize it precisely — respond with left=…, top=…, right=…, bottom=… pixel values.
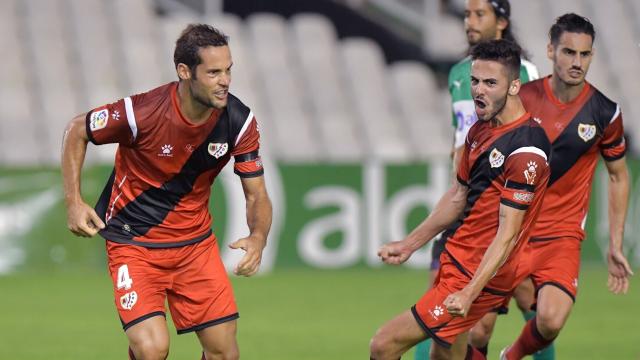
left=62, top=25, right=272, bottom=359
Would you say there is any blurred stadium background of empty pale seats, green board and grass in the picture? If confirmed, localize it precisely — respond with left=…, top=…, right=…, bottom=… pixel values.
left=0, top=0, right=640, bottom=359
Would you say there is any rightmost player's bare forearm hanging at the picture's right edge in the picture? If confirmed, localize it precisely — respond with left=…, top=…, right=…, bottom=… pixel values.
left=609, top=166, right=629, bottom=251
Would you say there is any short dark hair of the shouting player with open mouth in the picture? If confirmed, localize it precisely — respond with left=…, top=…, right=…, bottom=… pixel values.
left=471, top=39, right=522, bottom=80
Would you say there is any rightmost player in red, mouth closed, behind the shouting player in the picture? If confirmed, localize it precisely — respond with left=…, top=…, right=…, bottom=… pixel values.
left=501, top=13, right=633, bottom=359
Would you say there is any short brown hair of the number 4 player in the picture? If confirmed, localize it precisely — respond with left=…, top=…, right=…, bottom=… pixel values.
left=173, top=24, right=229, bottom=71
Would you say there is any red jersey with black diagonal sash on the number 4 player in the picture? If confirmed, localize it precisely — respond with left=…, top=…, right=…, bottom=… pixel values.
left=86, top=82, right=263, bottom=247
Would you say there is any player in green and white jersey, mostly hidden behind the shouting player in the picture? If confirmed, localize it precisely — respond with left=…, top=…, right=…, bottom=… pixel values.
left=415, top=0, right=554, bottom=360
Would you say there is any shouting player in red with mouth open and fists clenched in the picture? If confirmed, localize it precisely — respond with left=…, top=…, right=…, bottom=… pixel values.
left=370, top=40, right=551, bottom=360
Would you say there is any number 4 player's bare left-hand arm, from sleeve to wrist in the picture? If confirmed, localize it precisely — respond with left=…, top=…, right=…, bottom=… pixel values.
left=62, top=118, right=88, bottom=205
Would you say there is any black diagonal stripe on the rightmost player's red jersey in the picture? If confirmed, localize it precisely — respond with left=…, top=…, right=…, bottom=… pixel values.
left=548, top=92, right=616, bottom=186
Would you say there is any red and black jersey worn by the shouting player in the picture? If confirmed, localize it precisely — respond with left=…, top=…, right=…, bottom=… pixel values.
left=445, top=113, right=551, bottom=292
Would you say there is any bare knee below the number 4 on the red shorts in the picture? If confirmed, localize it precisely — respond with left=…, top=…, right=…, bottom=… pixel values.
left=125, top=315, right=169, bottom=358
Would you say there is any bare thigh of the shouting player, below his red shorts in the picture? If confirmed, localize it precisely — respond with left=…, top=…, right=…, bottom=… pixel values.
left=371, top=310, right=427, bottom=354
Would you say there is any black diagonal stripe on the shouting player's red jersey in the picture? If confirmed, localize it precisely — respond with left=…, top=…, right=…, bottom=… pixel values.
left=443, top=125, right=551, bottom=243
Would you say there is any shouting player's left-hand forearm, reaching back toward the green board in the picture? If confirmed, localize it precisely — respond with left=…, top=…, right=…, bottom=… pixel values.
left=406, top=185, right=466, bottom=251
